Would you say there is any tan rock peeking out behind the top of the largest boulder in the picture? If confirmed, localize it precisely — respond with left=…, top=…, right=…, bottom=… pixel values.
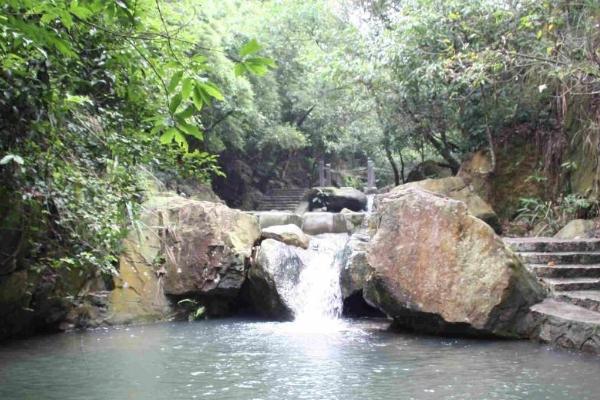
left=392, top=176, right=501, bottom=233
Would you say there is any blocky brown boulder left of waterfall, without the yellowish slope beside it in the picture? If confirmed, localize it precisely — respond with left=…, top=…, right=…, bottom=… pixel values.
left=158, top=197, right=260, bottom=299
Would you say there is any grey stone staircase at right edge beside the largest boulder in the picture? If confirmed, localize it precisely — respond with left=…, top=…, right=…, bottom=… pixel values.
left=505, top=238, right=600, bottom=354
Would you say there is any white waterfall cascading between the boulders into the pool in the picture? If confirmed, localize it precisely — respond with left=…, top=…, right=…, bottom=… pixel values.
left=288, top=234, right=348, bottom=329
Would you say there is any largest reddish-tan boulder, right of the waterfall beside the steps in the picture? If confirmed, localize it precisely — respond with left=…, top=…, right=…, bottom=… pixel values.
left=365, top=187, right=545, bottom=337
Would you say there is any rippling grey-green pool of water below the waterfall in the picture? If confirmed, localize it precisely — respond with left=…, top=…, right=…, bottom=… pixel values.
left=0, top=320, right=600, bottom=400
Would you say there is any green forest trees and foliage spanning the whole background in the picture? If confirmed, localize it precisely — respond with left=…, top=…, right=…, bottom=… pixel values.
left=0, top=0, right=600, bottom=273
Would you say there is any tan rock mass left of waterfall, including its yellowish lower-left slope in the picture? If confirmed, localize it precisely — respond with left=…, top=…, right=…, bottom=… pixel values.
left=108, top=193, right=260, bottom=324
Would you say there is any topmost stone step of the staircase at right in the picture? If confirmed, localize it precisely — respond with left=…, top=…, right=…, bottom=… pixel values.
left=504, top=237, right=600, bottom=253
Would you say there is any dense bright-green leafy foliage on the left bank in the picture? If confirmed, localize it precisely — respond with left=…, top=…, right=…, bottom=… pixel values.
left=0, top=0, right=274, bottom=272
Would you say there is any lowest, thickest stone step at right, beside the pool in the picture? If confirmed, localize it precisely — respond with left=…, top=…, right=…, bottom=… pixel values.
left=531, top=299, right=600, bottom=354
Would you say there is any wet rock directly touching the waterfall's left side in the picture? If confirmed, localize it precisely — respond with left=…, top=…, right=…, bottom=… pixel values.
left=248, top=239, right=303, bottom=320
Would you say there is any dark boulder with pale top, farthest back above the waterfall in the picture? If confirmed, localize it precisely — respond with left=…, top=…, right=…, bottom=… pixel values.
left=307, top=187, right=367, bottom=212
